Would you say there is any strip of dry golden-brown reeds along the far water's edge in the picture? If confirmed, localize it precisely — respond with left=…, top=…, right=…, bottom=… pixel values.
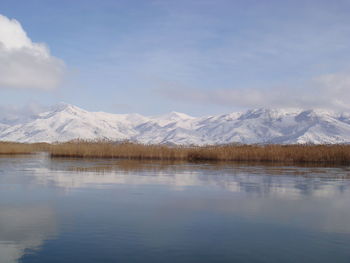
left=0, top=141, right=350, bottom=165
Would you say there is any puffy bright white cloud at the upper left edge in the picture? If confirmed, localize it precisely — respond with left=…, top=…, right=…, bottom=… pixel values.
left=0, top=15, right=64, bottom=90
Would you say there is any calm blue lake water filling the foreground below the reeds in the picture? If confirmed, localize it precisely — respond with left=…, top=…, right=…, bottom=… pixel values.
left=0, top=155, right=350, bottom=263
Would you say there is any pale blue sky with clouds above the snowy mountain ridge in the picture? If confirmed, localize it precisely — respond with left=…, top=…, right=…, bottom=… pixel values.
left=0, top=0, right=350, bottom=116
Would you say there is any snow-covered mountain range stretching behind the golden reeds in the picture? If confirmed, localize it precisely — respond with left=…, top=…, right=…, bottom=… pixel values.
left=0, top=103, right=350, bottom=145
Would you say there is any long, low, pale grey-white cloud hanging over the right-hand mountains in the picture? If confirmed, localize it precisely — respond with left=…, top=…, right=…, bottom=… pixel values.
left=157, top=73, right=350, bottom=110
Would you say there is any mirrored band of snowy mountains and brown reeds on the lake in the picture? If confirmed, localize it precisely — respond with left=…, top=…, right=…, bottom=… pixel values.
left=41, top=159, right=350, bottom=199
